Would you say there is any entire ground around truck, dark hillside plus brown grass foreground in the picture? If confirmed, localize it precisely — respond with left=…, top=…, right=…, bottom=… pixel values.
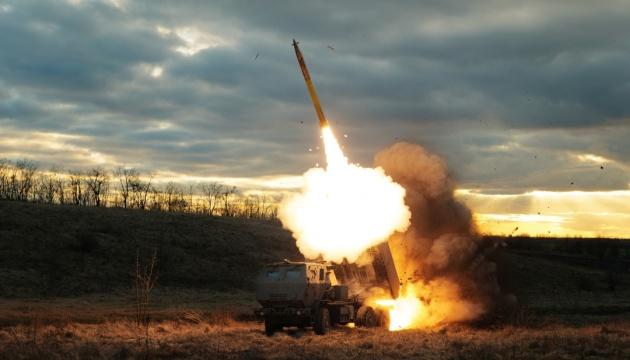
left=0, top=202, right=630, bottom=359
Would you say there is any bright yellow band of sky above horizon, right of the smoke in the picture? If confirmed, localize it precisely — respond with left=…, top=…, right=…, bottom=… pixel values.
left=457, top=189, right=630, bottom=238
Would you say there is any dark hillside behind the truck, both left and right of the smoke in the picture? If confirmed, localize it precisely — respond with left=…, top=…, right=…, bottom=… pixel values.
left=0, top=201, right=630, bottom=313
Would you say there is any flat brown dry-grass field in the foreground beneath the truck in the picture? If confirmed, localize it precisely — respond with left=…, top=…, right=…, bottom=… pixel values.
left=0, top=290, right=630, bottom=359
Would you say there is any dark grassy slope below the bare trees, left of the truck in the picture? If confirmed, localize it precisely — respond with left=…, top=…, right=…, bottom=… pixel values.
left=0, top=201, right=300, bottom=297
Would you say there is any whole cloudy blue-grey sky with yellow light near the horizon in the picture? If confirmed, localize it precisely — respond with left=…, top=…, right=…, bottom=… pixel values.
left=0, top=0, right=630, bottom=237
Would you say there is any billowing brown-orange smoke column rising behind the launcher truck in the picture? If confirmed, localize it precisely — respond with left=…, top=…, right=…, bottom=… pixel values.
left=374, top=143, right=512, bottom=326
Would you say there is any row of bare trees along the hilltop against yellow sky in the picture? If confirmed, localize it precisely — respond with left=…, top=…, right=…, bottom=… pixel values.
left=0, top=159, right=277, bottom=219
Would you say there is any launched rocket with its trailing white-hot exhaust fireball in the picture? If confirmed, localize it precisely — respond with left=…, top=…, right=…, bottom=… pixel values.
left=278, top=40, right=411, bottom=262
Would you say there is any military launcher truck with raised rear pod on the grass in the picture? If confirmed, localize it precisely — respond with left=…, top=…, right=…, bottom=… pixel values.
left=256, top=243, right=400, bottom=335
